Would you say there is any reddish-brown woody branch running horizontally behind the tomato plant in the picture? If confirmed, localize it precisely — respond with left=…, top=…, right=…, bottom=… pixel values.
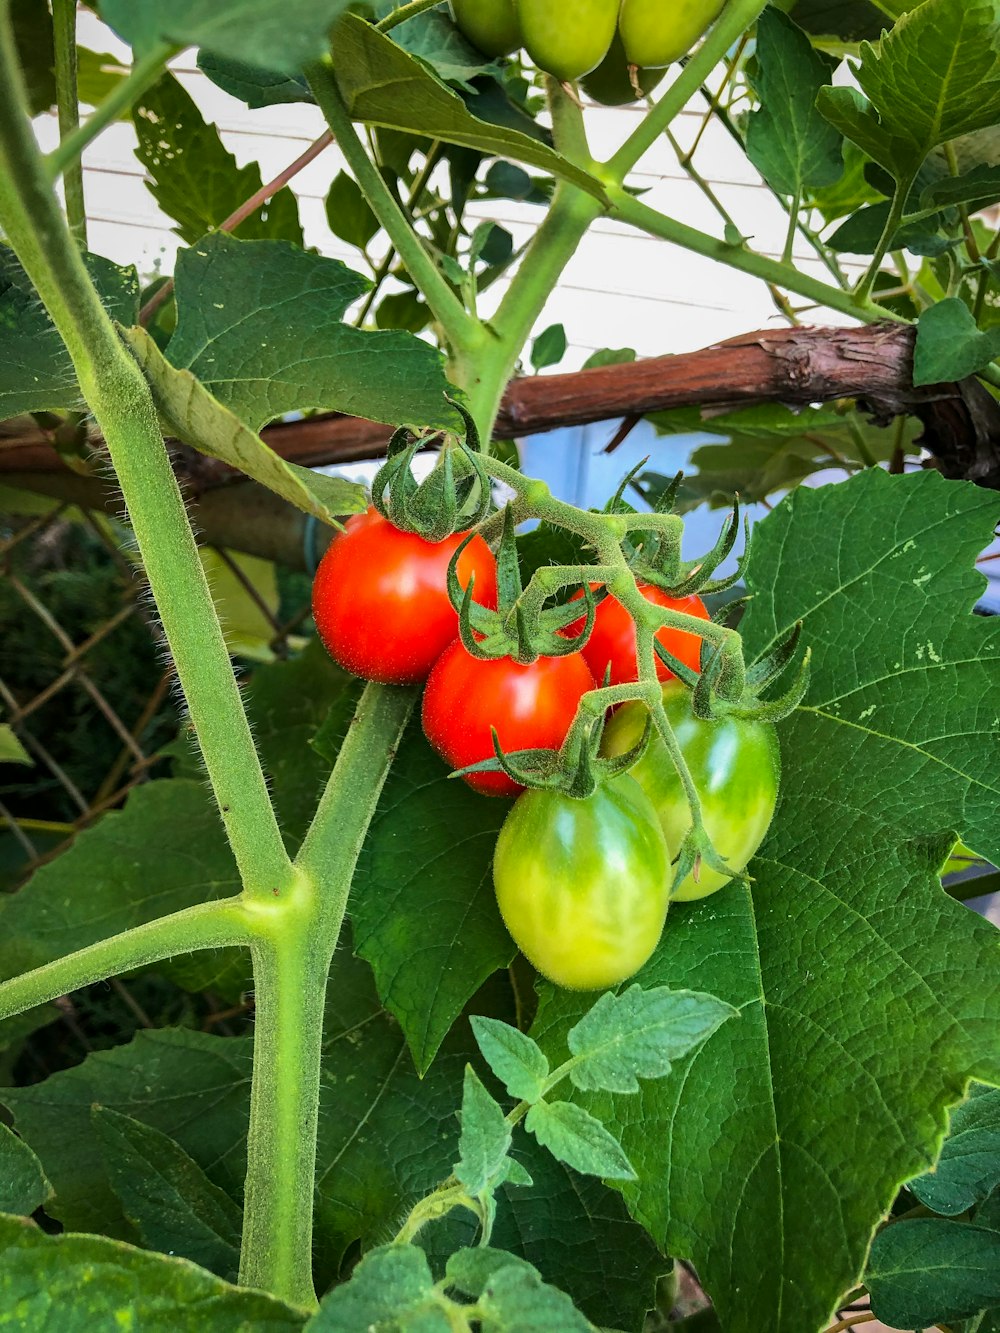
left=0, top=324, right=1000, bottom=491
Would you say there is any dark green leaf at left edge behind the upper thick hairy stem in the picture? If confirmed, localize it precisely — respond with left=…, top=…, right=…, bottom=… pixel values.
left=0, top=244, right=139, bottom=420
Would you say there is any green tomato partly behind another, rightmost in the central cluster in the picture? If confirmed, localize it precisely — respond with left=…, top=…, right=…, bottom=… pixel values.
left=601, top=681, right=780, bottom=902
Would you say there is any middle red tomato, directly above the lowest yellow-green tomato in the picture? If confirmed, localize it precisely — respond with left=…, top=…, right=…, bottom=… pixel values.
left=423, top=639, right=593, bottom=796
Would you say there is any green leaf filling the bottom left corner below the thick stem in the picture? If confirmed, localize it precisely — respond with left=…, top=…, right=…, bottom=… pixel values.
left=0, top=1217, right=305, bottom=1333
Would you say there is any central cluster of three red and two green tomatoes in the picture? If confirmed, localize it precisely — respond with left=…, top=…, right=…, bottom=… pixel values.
left=313, top=509, right=779, bottom=989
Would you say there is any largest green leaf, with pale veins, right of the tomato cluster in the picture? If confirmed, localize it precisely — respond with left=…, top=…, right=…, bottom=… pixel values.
left=535, top=469, right=1000, bottom=1333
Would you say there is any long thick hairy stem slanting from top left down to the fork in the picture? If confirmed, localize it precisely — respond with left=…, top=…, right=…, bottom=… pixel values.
left=0, top=11, right=291, bottom=894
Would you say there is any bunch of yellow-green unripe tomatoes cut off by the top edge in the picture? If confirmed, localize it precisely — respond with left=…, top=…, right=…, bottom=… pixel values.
left=451, top=0, right=725, bottom=107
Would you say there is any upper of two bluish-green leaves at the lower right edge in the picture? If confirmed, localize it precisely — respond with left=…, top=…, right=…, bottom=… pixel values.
left=907, top=1086, right=1000, bottom=1217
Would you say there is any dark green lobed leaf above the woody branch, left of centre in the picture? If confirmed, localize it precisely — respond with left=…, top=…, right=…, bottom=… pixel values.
left=167, top=232, right=457, bottom=431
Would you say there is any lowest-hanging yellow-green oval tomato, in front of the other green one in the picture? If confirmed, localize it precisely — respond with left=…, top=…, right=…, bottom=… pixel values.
left=493, top=776, right=669, bottom=990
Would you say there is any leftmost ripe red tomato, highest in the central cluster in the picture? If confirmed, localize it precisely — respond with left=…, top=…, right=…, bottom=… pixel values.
left=312, top=508, right=496, bottom=685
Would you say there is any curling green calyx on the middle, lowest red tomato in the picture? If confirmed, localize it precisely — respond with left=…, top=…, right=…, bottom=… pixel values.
left=448, top=505, right=605, bottom=665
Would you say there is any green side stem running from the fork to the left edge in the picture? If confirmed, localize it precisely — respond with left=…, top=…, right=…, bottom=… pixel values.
left=0, top=898, right=249, bottom=1018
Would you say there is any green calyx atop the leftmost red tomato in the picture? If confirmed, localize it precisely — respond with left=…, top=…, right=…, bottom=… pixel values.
left=372, top=399, right=493, bottom=541
